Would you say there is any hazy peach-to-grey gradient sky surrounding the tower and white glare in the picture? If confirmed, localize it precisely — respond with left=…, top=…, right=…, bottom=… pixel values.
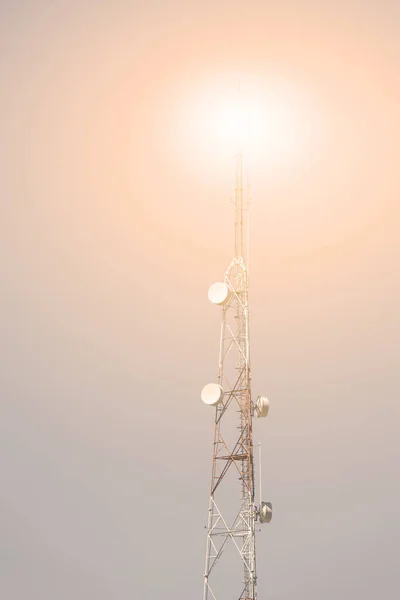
left=0, top=0, right=400, bottom=600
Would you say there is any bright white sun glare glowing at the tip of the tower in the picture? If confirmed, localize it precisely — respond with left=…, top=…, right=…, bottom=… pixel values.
left=178, top=80, right=318, bottom=165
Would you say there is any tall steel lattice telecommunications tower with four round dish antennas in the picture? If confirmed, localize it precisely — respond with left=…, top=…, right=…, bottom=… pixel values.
left=201, top=151, right=272, bottom=600
